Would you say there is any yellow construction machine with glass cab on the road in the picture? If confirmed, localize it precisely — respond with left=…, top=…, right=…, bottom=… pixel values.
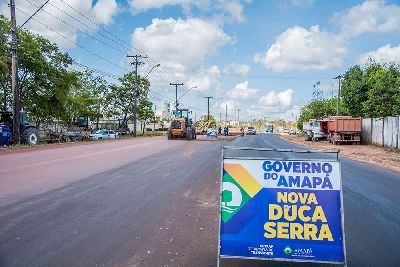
left=168, top=109, right=196, bottom=140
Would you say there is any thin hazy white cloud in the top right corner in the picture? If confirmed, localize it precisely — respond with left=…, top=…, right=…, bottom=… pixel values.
left=333, top=0, right=400, bottom=36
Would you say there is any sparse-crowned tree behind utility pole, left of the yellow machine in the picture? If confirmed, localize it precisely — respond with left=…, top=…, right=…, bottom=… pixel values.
left=106, top=72, right=150, bottom=127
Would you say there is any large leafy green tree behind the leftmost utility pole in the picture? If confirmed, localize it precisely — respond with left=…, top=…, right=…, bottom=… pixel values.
left=0, top=16, right=78, bottom=127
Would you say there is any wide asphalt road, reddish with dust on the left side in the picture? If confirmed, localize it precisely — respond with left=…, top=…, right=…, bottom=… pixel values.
left=0, top=134, right=400, bottom=266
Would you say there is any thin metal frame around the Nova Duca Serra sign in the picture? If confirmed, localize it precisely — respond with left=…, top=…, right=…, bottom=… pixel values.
left=217, top=146, right=347, bottom=267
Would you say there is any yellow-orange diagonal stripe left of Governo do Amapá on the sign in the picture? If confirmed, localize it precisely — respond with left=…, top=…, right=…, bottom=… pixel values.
left=224, top=163, right=262, bottom=197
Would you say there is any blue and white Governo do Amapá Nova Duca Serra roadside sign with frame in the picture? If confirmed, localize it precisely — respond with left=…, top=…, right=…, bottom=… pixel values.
left=218, top=147, right=346, bottom=265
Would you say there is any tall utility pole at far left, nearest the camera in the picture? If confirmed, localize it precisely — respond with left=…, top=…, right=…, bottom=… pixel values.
left=10, top=0, right=21, bottom=145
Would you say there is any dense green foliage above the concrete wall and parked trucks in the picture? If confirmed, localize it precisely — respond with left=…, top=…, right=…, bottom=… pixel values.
left=297, top=62, right=400, bottom=129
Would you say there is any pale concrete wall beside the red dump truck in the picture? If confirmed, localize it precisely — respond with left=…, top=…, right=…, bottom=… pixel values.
left=361, top=116, right=400, bottom=148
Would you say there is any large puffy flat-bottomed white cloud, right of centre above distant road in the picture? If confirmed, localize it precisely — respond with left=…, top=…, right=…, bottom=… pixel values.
left=254, top=25, right=347, bottom=71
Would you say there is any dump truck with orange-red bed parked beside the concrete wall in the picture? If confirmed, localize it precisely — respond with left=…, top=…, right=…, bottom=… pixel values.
left=325, top=116, right=362, bottom=145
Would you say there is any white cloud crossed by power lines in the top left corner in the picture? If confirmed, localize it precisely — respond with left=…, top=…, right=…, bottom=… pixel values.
left=0, top=0, right=117, bottom=49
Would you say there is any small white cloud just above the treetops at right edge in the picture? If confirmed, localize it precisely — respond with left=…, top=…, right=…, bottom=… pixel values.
left=357, top=44, right=400, bottom=64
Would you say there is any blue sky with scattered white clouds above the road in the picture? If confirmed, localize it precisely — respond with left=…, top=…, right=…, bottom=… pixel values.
left=0, top=0, right=400, bottom=120
